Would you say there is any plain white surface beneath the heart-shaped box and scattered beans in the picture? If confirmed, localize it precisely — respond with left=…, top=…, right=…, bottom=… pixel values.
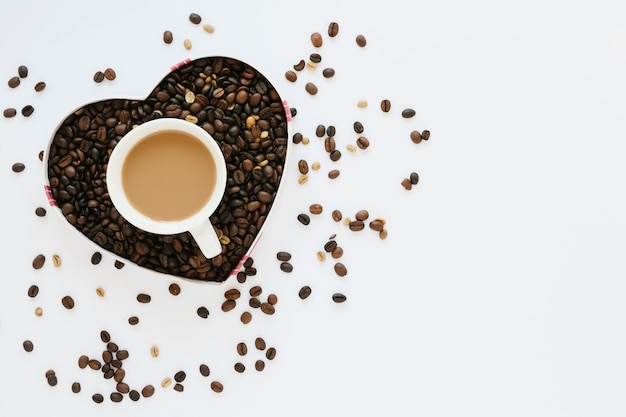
left=0, top=0, right=626, bottom=417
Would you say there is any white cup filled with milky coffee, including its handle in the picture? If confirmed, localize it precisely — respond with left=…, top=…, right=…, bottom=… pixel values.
left=107, top=118, right=227, bottom=258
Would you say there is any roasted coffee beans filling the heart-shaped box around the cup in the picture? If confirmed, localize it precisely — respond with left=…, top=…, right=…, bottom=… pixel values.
left=47, top=57, right=288, bottom=282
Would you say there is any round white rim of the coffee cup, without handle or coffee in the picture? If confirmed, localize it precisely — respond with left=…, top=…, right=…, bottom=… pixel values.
left=106, top=118, right=227, bottom=235
